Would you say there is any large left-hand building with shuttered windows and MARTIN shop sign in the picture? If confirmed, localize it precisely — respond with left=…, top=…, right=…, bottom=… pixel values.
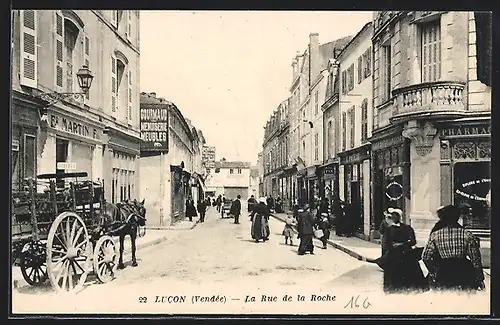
left=12, top=10, right=141, bottom=202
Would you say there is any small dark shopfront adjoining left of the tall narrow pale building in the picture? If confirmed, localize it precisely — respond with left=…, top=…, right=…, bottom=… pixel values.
left=320, top=162, right=340, bottom=216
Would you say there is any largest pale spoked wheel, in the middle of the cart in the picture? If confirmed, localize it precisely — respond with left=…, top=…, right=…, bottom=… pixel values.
left=47, top=211, right=92, bottom=292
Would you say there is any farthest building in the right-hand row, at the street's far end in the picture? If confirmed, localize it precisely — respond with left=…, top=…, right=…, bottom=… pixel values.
left=263, top=98, right=292, bottom=206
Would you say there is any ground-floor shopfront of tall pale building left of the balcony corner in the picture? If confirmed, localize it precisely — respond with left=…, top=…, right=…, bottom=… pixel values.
left=339, top=143, right=371, bottom=238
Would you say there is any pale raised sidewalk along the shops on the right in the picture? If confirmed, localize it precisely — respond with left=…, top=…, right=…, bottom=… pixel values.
left=271, top=213, right=491, bottom=276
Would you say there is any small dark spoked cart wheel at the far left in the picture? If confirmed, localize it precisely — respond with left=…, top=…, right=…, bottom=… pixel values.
left=19, top=241, right=48, bottom=286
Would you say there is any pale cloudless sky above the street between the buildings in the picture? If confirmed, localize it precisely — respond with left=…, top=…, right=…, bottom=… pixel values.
left=140, top=11, right=372, bottom=164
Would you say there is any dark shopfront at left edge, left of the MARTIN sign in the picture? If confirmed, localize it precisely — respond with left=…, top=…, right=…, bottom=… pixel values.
left=11, top=91, right=41, bottom=191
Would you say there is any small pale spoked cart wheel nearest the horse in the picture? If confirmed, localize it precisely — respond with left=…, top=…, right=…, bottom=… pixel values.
left=93, top=236, right=118, bottom=283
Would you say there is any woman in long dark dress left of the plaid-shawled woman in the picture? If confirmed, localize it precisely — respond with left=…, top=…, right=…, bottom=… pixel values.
left=376, top=209, right=428, bottom=293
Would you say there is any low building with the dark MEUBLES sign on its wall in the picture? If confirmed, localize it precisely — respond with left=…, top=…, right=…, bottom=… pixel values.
left=139, top=92, right=205, bottom=227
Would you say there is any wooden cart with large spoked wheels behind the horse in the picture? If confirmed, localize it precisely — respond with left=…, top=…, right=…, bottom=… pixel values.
left=12, top=172, right=118, bottom=291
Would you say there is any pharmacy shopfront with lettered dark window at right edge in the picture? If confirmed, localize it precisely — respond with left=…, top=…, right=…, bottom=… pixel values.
left=438, top=117, right=491, bottom=231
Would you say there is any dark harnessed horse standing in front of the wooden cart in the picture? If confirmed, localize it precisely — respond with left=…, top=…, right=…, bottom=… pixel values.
left=99, top=199, right=146, bottom=269
